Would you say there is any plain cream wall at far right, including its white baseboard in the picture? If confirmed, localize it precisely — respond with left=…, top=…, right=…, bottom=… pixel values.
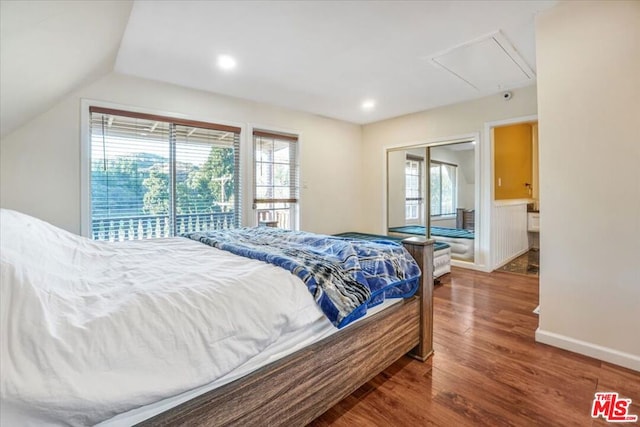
left=536, top=1, right=640, bottom=370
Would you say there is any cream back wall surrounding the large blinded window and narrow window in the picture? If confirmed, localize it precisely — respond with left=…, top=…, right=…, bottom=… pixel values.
left=0, top=73, right=363, bottom=233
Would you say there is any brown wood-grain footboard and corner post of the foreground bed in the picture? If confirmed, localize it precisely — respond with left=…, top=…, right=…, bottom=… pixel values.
left=138, top=237, right=433, bottom=426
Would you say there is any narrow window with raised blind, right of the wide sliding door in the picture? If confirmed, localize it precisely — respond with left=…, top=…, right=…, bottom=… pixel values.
left=253, top=130, right=298, bottom=230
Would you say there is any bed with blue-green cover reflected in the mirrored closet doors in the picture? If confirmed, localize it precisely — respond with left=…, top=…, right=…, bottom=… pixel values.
left=389, top=225, right=475, bottom=261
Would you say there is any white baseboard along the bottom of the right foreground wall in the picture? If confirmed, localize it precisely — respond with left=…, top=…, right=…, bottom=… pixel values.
left=536, top=328, right=640, bottom=372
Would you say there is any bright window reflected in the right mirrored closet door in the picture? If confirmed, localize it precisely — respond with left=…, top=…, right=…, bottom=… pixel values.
left=430, top=160, right=458, bottom=216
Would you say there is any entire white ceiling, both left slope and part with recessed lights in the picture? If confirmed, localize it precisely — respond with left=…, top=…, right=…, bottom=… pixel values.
left=0, top=0, right=556, bottom=135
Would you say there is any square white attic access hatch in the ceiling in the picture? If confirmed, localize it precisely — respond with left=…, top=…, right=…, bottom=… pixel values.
left=431, top=31, right=536, bottom=92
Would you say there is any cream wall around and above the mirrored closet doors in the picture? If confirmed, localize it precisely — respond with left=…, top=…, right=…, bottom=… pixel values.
left=359, top=86, right=537, bottom=234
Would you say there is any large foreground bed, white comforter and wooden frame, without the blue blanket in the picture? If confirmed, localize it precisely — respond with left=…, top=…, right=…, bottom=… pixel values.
left=0, top=210, right=433, bottom=425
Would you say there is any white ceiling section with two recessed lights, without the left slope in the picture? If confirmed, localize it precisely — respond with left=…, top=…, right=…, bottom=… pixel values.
left=116, top=0, right=556, bottom=123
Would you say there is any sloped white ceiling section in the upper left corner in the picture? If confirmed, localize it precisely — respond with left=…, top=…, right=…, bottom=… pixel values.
left=0, top=0, right=132, bottom=136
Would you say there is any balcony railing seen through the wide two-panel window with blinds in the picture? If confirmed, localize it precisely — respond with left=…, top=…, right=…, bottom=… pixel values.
left=91, top=212, right=235, bottom=242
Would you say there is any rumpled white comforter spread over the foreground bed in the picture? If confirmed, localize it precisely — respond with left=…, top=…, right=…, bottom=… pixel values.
left=0, top=210, right=323, bottom=425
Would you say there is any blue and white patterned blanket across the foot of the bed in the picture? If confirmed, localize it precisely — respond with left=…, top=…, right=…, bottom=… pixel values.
left=183, top=227, right=420, bottom=328
